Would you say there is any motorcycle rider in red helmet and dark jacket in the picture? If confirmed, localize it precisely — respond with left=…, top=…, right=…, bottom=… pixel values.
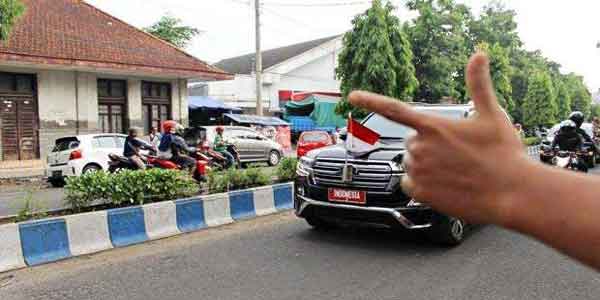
left=158, top=121, right=196, bottom=174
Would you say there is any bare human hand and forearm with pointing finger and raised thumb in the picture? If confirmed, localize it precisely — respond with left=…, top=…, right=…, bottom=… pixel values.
left=349, top=54, right=600, bottom=270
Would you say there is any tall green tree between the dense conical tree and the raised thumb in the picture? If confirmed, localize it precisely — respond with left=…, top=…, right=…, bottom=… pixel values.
left=405, top=0, right=471, bottom=103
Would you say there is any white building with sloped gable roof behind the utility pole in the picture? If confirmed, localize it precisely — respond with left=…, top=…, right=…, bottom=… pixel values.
left=190, top=35, right=342, bottom=113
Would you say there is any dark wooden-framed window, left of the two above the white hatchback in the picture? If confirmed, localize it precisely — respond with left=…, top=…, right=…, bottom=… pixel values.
left=98, top=79, right=127, bottom=133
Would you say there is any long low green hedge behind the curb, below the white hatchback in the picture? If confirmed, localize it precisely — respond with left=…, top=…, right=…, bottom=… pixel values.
left=65, top=169, right=199, bottom=211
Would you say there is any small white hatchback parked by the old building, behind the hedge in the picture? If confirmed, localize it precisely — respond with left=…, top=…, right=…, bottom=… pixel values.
left=46, top=133, right=127, bottom=187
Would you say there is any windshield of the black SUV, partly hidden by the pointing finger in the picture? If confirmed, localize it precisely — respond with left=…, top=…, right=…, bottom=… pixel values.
left=363, top=109, right=465, bottom=139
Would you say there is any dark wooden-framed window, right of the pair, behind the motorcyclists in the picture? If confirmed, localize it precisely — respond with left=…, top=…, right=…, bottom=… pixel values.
left=142, top=81, right=172, bottom=133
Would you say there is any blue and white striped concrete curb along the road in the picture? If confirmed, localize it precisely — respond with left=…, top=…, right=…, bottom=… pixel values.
left=0, top=183, right=293, bottom=272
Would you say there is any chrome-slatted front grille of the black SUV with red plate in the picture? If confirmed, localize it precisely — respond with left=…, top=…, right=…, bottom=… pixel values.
left=313, top=159, right=392, bottom=191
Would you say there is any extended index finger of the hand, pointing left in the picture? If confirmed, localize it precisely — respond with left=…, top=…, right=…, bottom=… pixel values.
left=348, top=91, right=442, bottom=133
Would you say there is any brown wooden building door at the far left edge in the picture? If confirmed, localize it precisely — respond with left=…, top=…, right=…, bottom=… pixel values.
left=0, top=73, right=39, bottom=160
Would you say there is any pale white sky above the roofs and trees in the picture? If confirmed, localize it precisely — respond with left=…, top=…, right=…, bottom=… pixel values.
left=86, top=0, right=600, bottom=91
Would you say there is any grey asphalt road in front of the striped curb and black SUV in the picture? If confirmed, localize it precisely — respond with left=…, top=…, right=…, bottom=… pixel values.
left=0, top=212, right=600, bottom=300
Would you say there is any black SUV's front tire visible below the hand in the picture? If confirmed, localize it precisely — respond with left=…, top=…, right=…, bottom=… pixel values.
left=427, top=214, right=466, bottom=246
